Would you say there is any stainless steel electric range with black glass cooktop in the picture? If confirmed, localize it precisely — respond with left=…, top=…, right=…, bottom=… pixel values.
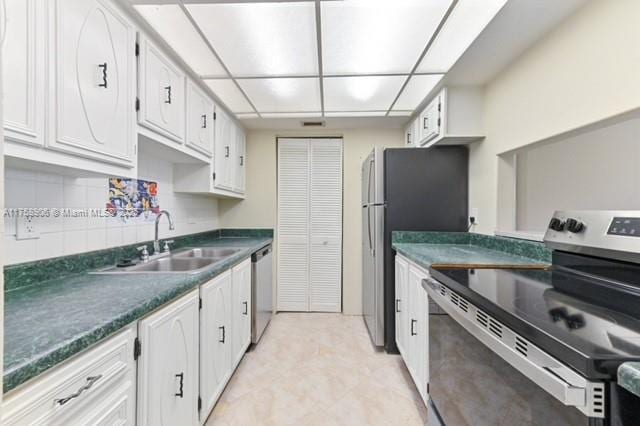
left=423, top=211, right=640, bottom=426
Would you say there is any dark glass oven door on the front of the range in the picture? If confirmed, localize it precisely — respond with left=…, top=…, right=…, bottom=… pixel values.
left=424, top=281, right=606, bottom=426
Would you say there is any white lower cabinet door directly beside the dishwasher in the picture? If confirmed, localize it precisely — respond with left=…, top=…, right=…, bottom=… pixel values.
left=232, top=259, right=252, bottom=367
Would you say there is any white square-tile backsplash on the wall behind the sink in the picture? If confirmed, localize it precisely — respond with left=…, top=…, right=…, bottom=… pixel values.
left=4, top=157, right=219, bottom=264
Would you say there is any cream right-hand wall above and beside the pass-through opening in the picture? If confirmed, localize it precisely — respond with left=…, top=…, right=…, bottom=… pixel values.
left=469, top=0, right=640, bottom=234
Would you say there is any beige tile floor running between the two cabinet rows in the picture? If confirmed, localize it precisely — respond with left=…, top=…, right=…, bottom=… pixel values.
left=207, top=313, right=427, bottom=426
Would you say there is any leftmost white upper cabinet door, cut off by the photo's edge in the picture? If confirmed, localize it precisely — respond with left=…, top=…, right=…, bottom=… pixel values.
left=2, top=0, right=46, bottom=145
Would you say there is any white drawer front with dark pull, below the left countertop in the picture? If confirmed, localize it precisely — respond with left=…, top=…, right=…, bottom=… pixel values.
left=2, top=327, right=136, bottom=425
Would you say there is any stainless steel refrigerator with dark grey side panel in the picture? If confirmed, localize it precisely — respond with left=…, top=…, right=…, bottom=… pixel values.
left=362, top=146, right=468, bottom=353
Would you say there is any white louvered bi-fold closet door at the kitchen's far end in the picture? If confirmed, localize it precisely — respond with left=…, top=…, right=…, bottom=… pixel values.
left=277, top=138, right=342, bottom=312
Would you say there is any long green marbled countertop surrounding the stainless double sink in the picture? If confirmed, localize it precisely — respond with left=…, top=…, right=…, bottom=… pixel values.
left=4, top=232, right=272, bottom=392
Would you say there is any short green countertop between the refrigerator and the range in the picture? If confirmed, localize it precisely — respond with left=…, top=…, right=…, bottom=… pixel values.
left=392, top=232, right=551, bottom=269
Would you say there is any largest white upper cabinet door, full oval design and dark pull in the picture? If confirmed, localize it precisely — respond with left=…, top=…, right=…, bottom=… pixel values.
left=47, top=0, right=136, bottom=167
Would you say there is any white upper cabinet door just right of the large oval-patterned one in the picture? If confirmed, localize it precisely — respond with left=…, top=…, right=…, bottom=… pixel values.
left=139, top=38, right=185, bottom=143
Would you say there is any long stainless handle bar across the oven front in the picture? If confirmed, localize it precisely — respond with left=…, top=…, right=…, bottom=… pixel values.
left=423, top=277, right=592, bottom=412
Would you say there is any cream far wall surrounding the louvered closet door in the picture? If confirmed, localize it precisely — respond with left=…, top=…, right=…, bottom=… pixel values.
left=219, top=128, right=403, bottom=315
